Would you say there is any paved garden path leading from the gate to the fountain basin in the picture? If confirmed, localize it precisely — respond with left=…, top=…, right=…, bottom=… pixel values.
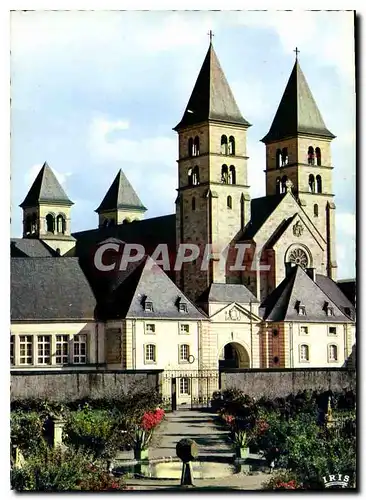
left=149, top=410, right=233, bottom=458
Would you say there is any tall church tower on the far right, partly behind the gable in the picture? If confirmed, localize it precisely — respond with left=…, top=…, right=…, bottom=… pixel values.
left=262, top=55, right=337, bottom=280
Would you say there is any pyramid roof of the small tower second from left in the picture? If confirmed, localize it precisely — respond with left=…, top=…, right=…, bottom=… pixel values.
left=96, top=170, right=147, bottom=213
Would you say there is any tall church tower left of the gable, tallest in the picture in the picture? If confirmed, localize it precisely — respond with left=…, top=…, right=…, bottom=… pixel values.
left=174, top=41, right=250, bottom=300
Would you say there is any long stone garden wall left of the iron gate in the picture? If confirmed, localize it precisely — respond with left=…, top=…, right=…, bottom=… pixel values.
left=10, top=370, right=162, bottom=401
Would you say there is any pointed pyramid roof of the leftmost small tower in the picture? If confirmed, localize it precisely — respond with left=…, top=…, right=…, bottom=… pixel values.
left=19, top=162, right=73, bottom=208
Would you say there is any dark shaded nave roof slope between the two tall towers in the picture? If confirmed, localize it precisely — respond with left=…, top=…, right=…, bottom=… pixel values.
left=240, top=193, right=286, bottom=240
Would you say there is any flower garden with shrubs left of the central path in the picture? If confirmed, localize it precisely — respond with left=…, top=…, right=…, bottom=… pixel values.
left=11, top=387, right=164, bottom=491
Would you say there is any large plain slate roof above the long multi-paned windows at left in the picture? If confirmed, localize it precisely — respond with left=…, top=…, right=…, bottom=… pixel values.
left=10, top=257, right=96, bottom=322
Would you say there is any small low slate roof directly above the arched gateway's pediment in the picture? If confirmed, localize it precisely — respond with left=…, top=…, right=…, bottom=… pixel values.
left=197, top=283, right=258, bottom=304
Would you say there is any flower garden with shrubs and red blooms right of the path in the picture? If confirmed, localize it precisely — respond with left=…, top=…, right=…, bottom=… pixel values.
left=212, top=389, right=356, bottom=490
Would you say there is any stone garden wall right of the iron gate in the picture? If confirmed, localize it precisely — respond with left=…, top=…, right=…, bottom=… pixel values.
left=220, top=368, right=356, bottom=398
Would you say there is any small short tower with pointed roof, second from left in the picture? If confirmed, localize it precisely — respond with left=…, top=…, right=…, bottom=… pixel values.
left=96, top=170, right=147, bottom=227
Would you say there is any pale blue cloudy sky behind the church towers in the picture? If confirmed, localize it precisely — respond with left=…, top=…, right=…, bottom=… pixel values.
left=10, top=11, right=356, bottom=279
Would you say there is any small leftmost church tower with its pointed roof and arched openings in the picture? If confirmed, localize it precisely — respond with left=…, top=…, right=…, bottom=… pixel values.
left=19, top=162, right=75, bottom=255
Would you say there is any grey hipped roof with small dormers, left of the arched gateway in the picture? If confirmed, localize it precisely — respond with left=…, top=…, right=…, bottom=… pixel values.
left=105, top=257, right=206, bottom=321
